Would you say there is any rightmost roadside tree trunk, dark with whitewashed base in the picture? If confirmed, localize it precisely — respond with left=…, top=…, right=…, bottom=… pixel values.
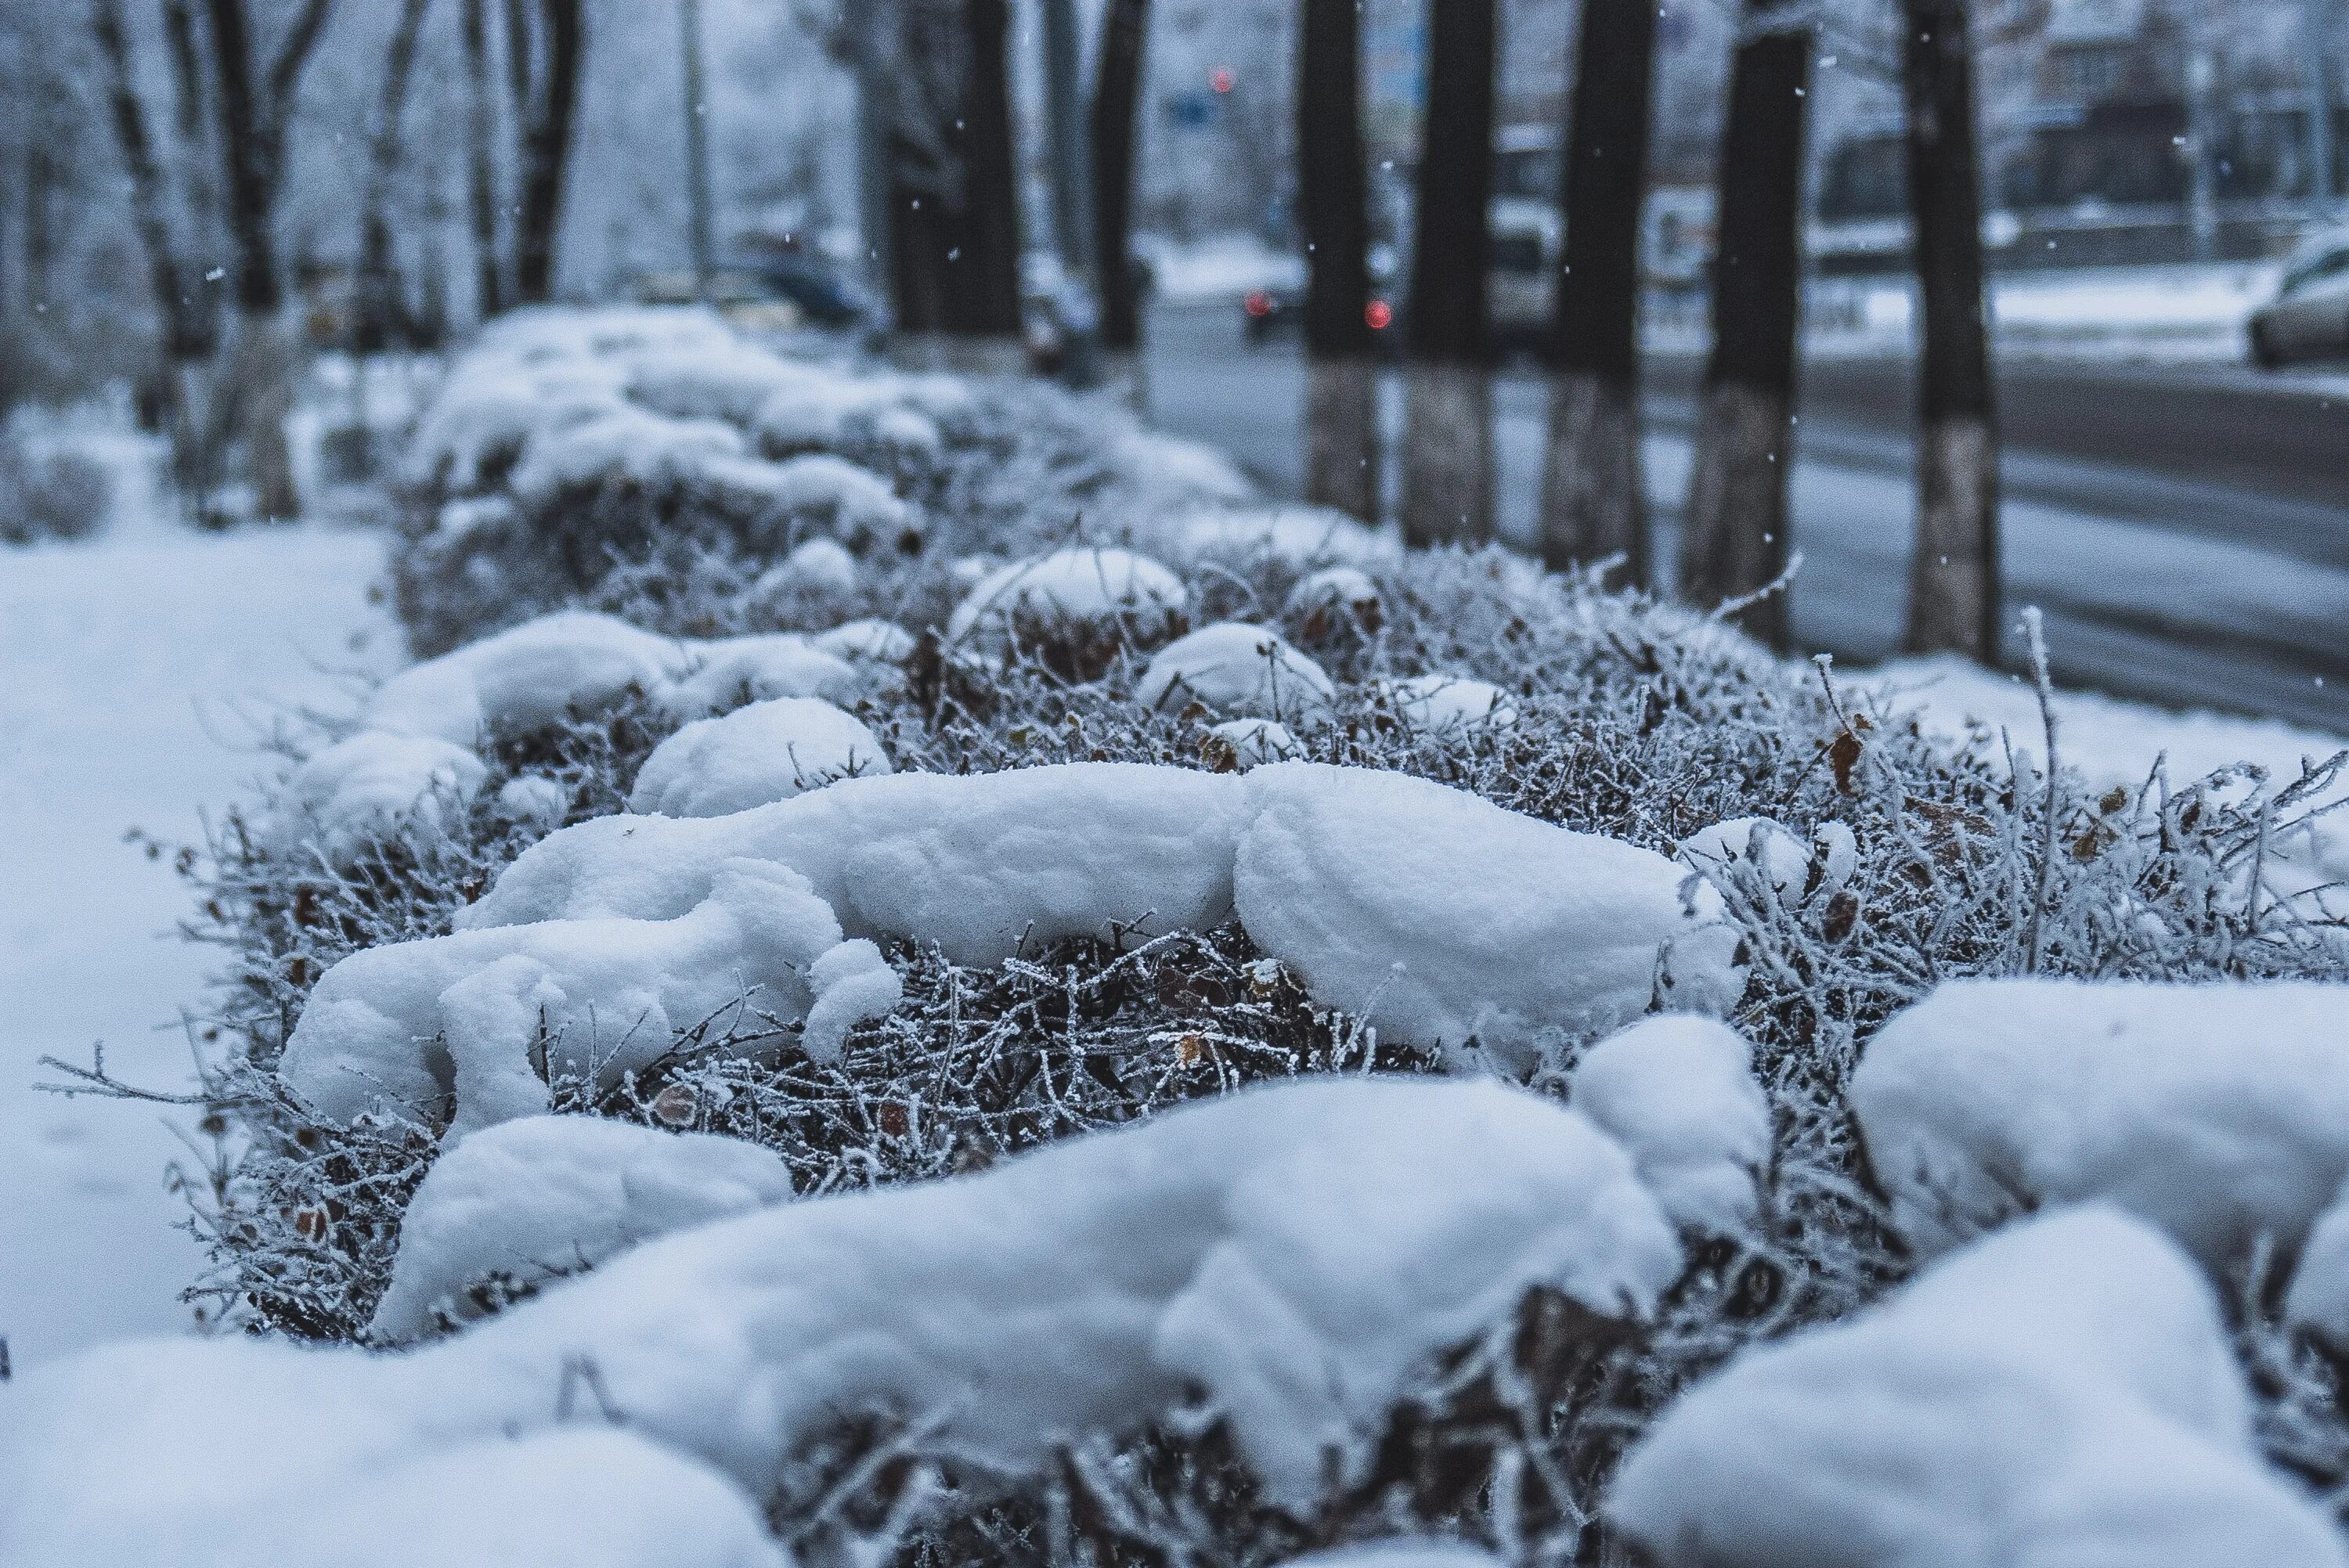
left=1903, top=0, right=1999, bottom=665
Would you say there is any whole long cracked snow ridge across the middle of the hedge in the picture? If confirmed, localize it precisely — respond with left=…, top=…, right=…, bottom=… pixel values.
left=458, top=763, right=1743, bottom=1065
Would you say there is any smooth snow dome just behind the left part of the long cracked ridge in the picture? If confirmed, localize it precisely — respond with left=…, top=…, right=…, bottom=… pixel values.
left=627, top=697, right=893, bottom=816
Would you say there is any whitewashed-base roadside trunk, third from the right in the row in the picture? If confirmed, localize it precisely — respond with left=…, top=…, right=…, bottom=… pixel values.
left=1541, top=0, right=1656, bottom=585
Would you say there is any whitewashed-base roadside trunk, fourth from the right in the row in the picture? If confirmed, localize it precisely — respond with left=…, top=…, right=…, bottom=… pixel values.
left=1402, top=0, right=1496, bottom=545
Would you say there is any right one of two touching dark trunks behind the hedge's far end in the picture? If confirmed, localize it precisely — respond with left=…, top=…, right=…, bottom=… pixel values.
left=944, top=0, right=1019, bottom=341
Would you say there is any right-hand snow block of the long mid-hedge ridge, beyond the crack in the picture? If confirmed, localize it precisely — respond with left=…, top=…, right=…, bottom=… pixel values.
left=1233, top=763, right=1741, bottom=1068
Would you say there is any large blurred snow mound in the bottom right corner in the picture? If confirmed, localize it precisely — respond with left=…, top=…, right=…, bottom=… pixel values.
left=1604, top=1206, right=2349, bottom=1568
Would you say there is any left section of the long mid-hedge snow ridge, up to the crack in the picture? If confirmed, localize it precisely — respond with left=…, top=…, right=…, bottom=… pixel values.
left=458, top=763, right=1245, bottom=964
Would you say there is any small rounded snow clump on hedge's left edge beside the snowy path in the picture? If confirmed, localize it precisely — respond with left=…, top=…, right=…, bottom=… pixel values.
left=263, top=730, right=486, bottom=866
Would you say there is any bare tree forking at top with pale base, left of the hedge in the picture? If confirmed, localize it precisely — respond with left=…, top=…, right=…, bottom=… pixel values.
left=204, top=0, right=334, bottom=517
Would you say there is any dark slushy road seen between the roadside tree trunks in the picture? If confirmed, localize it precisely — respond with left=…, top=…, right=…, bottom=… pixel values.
left=1149, top=305, right=2349, bottom=733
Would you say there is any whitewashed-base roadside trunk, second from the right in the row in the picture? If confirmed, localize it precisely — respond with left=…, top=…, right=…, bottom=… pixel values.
left=1680, top=0, right=1813, bottom=646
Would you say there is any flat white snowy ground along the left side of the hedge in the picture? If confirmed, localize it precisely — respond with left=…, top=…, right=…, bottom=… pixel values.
left=0, top=503, right=397, bottom=1366
